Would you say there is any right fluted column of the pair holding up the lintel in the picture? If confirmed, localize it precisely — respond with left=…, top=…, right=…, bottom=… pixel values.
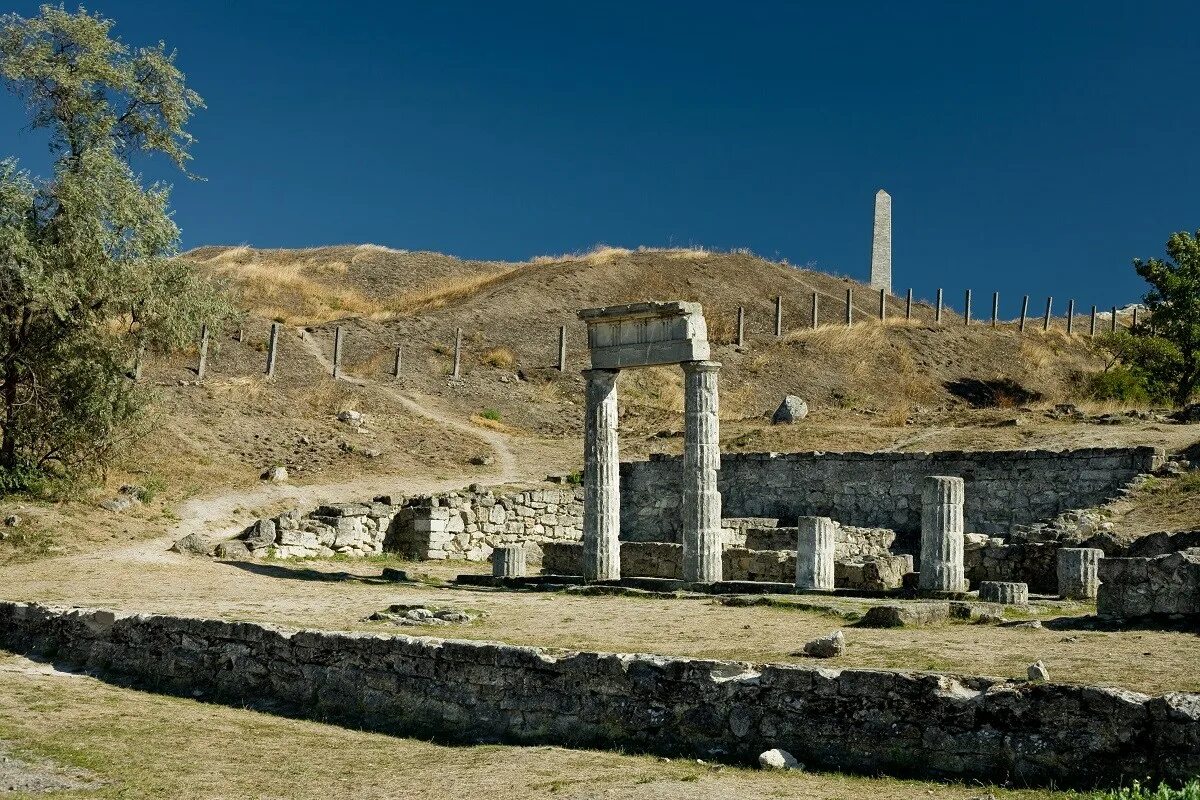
left=680, top=361, right=722, bottom=583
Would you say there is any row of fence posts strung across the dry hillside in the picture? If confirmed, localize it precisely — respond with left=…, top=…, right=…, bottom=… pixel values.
left=182, top=288, right=1138, bottom=380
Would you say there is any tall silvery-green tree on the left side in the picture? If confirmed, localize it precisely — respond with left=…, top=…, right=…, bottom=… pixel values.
left=0, top=6, right=232, bottom=491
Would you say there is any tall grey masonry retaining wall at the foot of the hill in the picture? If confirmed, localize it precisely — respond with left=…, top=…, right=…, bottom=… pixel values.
left=620, top=447, right=1162, bottom=541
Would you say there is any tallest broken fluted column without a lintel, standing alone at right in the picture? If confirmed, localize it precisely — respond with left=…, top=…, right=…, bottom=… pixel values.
left=919, top=475, right=967, bottom=594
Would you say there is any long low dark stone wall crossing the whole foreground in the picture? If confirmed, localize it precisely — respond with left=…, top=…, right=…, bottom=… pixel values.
left=0, top=603, right=1200, bottom=787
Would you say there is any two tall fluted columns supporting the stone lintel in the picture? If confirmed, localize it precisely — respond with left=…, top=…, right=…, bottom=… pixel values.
left=583, top=361, right=722, bottom=583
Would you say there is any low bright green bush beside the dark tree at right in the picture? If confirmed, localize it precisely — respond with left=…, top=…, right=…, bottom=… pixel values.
left=1086, top=331, right=1182, bottom=404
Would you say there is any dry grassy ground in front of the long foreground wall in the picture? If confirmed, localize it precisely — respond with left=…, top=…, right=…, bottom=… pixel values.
left=0, top=656, right=1073, bottom=800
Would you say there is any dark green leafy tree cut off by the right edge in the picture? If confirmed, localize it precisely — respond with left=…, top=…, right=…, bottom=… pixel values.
left=1133, top=231, right=1200, bottom=405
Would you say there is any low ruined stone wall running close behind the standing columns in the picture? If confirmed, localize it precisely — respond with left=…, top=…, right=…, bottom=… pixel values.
left=541, top=542, right=912, bottom=591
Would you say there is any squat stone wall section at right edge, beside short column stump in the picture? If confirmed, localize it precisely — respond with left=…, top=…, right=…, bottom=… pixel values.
left=1096, top=547, right=1200, bottom=619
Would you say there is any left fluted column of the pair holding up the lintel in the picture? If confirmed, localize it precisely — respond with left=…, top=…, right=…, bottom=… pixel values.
left=583, top=369, right=620, bottom=582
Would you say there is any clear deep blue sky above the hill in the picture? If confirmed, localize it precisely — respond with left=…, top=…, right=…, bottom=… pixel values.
left=0, top=0, right=1200, bottom=315
